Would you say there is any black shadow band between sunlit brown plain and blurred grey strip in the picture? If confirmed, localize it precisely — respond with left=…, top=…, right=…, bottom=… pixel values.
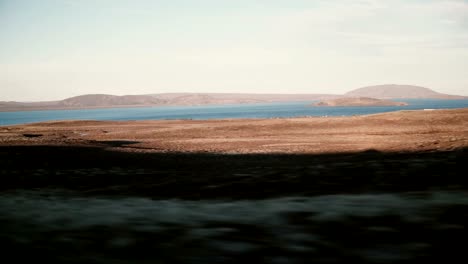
left=0, top=145, right=468, bottom=199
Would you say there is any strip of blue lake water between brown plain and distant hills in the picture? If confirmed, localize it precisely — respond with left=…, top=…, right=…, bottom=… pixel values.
left=0, top=99, right=468, bottom=125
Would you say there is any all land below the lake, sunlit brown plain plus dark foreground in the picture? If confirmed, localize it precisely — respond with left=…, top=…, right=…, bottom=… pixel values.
left=0, top=109, right=468, bottom=263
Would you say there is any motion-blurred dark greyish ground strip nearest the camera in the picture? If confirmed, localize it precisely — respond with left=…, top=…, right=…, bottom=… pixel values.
left=0, top=190, right=468, bottom=263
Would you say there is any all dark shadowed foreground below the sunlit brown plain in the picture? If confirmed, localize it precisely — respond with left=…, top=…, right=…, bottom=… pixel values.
left=0, top=146, right=468, bottom=263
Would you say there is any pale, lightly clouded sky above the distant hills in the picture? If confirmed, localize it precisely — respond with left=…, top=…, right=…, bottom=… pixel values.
left=0, top=0, right=468, bottom=101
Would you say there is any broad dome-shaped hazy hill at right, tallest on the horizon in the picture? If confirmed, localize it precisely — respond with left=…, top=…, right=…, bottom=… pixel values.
left=345, top=84, right=466, bottom=99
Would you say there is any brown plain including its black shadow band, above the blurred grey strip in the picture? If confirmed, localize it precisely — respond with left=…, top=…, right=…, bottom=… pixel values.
left=0, top=109, right=468, bottom=199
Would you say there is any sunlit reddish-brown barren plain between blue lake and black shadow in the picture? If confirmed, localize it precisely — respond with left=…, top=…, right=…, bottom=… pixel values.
left=0, top=106, right=468, bottom=154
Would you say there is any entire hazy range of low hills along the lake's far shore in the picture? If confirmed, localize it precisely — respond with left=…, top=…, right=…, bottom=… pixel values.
left=0, top=84, right=468, bottom=111
